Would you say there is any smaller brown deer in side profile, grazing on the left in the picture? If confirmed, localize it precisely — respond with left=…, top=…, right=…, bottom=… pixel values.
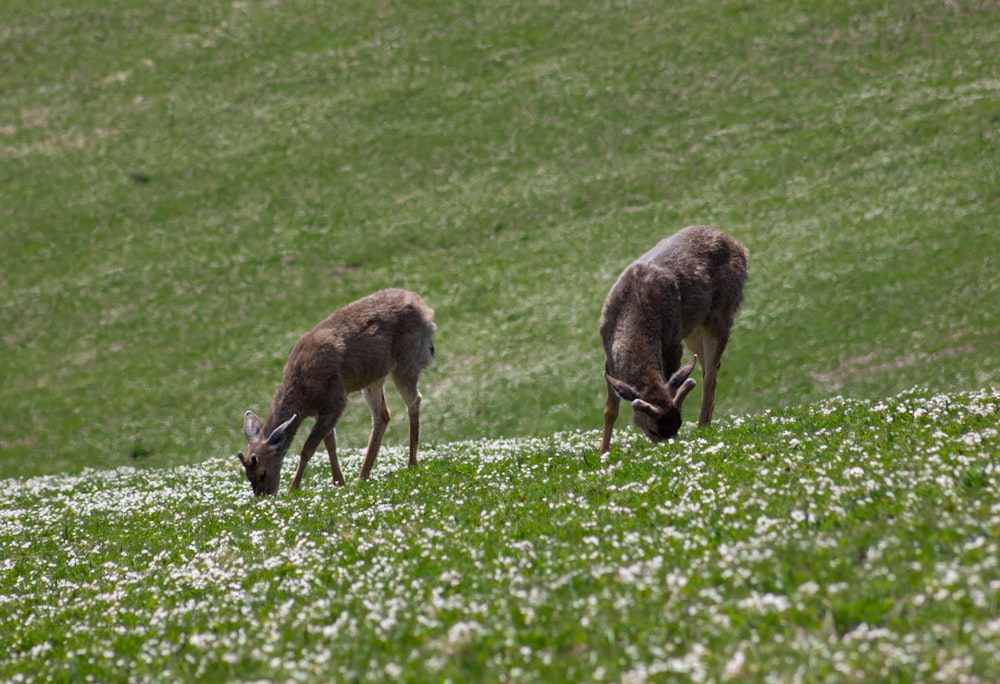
left=237, top=289, right=434, bottom=496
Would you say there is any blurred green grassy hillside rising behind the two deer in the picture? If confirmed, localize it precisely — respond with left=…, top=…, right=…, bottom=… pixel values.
left=0, top=0, right=1000, bottom=476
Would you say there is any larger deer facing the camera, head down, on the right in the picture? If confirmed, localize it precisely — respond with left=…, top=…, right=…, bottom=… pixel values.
left=600, top=226, right=747, bottom=454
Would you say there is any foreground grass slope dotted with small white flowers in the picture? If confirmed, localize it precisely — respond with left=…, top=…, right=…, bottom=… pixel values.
left=0, top=389, right=1000, bottom=682
